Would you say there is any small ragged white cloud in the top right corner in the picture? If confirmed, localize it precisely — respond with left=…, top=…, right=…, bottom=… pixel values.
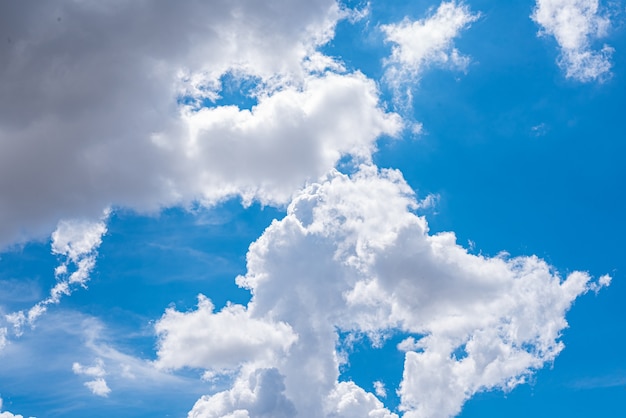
left=532, top=0, right=613, bottom=82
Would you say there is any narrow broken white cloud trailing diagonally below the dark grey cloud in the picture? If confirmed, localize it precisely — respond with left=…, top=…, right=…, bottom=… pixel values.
left=5, top=216, right=109, bottom=336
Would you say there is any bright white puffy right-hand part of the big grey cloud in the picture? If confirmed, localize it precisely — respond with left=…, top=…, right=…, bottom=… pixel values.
left=173, top=73, right=401, bottom=203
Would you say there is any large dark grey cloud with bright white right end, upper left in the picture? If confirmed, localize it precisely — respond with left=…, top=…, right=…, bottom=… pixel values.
left=0, top=0, right=400, bottom=248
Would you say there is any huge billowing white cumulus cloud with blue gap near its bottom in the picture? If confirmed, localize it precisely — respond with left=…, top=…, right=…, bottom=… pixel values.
left=157, top=165, right=609, bottom=417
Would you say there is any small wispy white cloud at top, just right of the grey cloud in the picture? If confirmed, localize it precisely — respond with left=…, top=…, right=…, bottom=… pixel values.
left=381, top=1, right=479, bottom=86
